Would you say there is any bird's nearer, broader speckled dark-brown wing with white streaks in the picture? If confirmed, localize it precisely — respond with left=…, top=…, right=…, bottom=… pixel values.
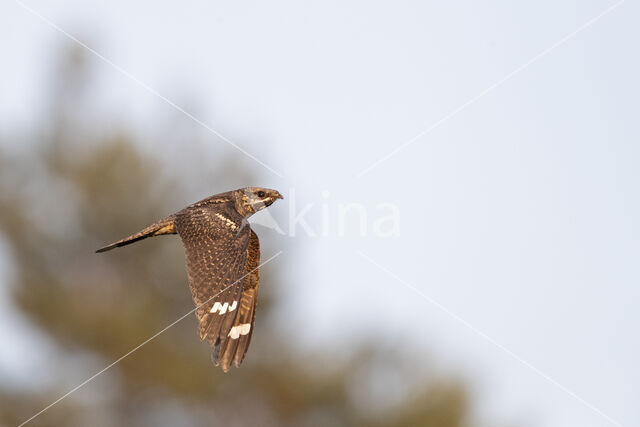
left=176, top=209, right=252, bottom=371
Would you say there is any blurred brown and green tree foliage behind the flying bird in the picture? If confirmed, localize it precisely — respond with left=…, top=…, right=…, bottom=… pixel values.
left=0, top=45, right=468, bottom=427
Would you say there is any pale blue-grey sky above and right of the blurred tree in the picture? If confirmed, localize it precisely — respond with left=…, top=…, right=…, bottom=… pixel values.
left=0, top=0, right=640, bottom=427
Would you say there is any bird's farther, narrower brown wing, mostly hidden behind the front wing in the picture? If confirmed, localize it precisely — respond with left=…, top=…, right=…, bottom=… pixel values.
left=216, top=230, right=260, bottom=370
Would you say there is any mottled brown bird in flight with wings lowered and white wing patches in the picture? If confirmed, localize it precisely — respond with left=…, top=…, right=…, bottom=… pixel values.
left=96, top=187, right=282, bottom=372
